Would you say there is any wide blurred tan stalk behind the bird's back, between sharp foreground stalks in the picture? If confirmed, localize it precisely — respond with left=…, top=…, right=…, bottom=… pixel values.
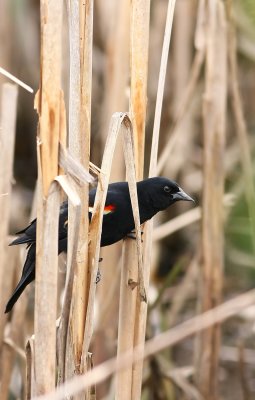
left=98, top=0, right=130, bottom=352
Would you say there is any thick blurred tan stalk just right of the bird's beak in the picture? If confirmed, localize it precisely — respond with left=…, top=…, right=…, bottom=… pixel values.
left=196, top=0, right=227, bottom=400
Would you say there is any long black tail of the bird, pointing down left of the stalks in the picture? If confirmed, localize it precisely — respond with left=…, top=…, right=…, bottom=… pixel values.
left=5, top=243, right=36, bottom=313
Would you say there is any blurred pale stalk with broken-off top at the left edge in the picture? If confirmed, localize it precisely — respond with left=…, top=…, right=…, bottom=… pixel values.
left=0, top=83, right=18, bottom=348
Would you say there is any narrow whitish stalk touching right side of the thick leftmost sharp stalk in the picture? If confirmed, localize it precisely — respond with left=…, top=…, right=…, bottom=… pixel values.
left=64, top=0, right=81, bottom=379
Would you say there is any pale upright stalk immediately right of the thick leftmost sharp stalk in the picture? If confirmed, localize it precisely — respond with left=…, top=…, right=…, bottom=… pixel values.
left=65, top=0, right=84, bottom=372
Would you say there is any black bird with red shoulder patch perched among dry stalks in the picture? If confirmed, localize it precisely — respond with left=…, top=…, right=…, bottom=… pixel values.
left=5, top=178, right=192, bottom=313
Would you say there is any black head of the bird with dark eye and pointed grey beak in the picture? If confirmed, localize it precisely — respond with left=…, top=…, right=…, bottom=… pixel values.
left=140, top=177, right=194, bottom=211
